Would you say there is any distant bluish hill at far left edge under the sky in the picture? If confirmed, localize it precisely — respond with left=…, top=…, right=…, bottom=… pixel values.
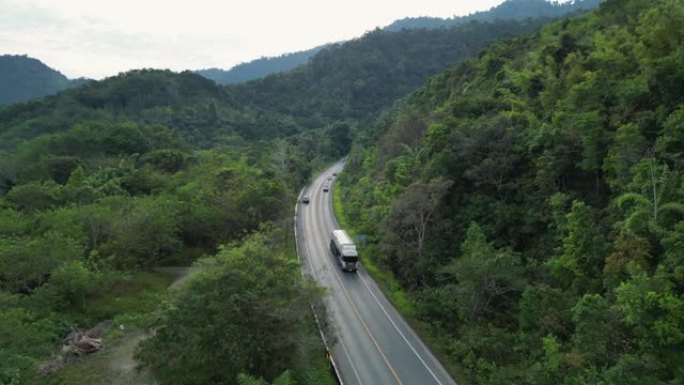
left=0, top=55, right=84, bottom=105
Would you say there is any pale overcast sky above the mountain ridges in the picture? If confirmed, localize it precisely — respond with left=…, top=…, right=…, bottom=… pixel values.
left=0, top=0, right=510, bottom=79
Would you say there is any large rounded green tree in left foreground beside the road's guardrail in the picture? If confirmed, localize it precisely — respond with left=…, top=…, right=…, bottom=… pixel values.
left=136, top=231, right=320, bottom=384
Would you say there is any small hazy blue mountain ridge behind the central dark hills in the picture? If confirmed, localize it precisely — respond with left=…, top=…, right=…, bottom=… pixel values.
left=195, top=46, right=325, bottom=84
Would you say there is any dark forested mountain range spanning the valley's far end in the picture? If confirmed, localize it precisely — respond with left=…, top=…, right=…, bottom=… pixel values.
left=0, top=14, right=548, bottom=148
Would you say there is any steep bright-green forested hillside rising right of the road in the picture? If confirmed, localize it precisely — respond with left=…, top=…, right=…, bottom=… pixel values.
left=339, top=0, right=684, bottom=385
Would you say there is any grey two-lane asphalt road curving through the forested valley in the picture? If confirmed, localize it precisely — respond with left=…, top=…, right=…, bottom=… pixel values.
left=296, top=163, right=456, bottom=385
